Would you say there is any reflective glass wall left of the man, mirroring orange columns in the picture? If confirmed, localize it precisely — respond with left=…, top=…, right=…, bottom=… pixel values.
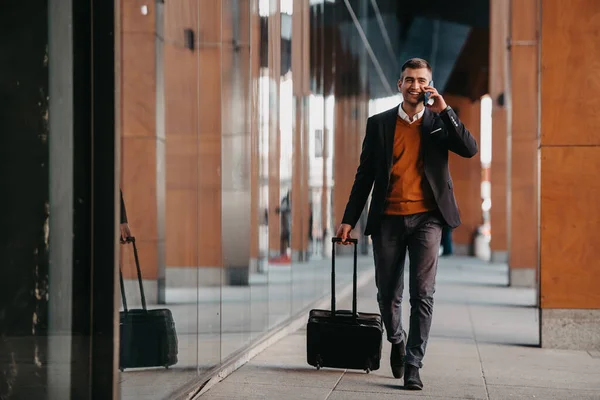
left=118, top=0, right=378, bottom=399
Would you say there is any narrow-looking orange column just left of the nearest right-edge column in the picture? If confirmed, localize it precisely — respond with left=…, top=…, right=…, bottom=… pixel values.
left=508, top=0, right=539, bottom=287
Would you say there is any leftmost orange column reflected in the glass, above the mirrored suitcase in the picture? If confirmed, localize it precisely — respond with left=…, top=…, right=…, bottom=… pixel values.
left=119, top=0, right=162, bottom=302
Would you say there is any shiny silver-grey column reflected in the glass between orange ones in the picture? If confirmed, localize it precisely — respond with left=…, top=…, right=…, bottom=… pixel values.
left=220, top=1, right=252, bottom=285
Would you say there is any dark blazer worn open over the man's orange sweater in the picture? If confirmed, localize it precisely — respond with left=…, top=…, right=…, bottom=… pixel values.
left=342, top=105, right=477, bottom=235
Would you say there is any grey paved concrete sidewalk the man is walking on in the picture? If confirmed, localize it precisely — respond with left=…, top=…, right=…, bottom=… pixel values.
left=200, top=257, right=600, bottom=400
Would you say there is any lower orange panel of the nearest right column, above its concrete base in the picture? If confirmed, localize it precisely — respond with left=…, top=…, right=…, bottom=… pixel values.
left=541, top=146, right=600, bottom=308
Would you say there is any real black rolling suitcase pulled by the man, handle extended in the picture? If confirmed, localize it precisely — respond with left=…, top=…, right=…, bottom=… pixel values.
left=306, top=238, right=383, bottom=373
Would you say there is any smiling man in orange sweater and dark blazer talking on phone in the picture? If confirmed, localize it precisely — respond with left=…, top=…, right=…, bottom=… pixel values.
left=337, top=58, right=477, bottom=390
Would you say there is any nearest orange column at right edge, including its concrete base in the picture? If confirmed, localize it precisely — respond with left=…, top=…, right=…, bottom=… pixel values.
left=540, top=0, right=600, bottom=350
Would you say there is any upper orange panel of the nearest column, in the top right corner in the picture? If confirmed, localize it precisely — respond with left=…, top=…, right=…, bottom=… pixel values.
left=541, top=0, right=600, bottom=146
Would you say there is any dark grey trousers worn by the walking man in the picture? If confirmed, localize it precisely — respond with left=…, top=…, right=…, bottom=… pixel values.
left=372, top=210, right=443, bottom=368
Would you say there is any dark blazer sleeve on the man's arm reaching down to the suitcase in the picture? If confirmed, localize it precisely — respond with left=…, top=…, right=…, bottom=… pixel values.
left=342, top=117, right=377, bottom=228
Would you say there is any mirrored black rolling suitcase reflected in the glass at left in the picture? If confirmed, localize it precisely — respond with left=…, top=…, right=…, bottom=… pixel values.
left=119, top=237, right=178, bottom=371
